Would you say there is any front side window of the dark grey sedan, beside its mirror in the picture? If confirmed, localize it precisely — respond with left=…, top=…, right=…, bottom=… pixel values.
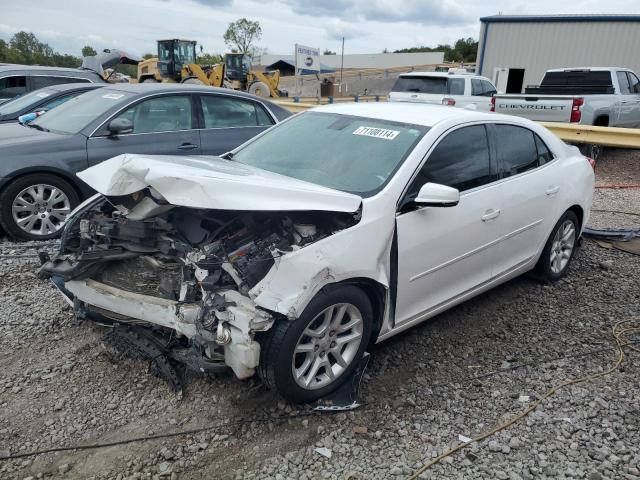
left=117, top=95, right=192, bottom=133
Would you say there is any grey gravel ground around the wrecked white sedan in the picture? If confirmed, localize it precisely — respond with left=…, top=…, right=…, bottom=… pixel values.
left=0, top=150, right=640, bottom=480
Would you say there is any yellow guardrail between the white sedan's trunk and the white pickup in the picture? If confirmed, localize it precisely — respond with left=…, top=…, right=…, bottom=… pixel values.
left=540, top=122, right=640, bottom=148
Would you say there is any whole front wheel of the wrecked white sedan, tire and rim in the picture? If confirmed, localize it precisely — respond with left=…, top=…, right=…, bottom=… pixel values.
left=259, top=285, right=373, bottom=403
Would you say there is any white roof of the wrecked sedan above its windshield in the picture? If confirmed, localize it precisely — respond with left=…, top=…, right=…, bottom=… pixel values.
left=312, top=102, right=530, bottom=127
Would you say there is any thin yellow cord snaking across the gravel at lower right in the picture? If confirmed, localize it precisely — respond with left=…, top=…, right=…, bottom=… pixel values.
left=408, top=317, right=640, bottom=480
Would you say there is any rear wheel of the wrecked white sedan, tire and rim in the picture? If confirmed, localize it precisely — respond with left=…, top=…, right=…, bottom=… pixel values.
left=536, top=210, right=580, bottom=282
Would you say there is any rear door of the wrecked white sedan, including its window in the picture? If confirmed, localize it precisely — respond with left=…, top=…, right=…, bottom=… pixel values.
left=490, top=124, right=562, bottom=275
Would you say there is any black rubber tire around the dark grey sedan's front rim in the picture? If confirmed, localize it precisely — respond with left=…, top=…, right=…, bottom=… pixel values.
left=0, top=173, right=80, bottom=240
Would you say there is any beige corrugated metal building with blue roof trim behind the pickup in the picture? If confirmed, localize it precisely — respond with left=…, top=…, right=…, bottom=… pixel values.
left=477, top=15, right=640, bottom=93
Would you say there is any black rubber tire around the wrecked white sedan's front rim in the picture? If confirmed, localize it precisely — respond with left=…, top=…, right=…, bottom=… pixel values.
left=258, top=285, right=373, bottom=403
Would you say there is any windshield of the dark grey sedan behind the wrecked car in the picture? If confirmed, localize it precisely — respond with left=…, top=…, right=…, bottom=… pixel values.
left=30, top=88, right=134, bottom=134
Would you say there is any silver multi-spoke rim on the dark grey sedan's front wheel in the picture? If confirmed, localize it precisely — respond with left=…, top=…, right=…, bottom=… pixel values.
left=11, top=184, right=71, bottom=235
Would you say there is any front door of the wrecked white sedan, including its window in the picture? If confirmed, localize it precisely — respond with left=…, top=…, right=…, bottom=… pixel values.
left=395, top=124, right=502, bottom=326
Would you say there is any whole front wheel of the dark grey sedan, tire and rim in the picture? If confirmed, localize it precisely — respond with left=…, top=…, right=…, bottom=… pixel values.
left=0, top=173, right=80, bottom=240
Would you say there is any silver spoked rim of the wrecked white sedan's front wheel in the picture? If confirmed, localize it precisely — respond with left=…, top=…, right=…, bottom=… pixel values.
left=291, top=303, right=364, bottom=390
